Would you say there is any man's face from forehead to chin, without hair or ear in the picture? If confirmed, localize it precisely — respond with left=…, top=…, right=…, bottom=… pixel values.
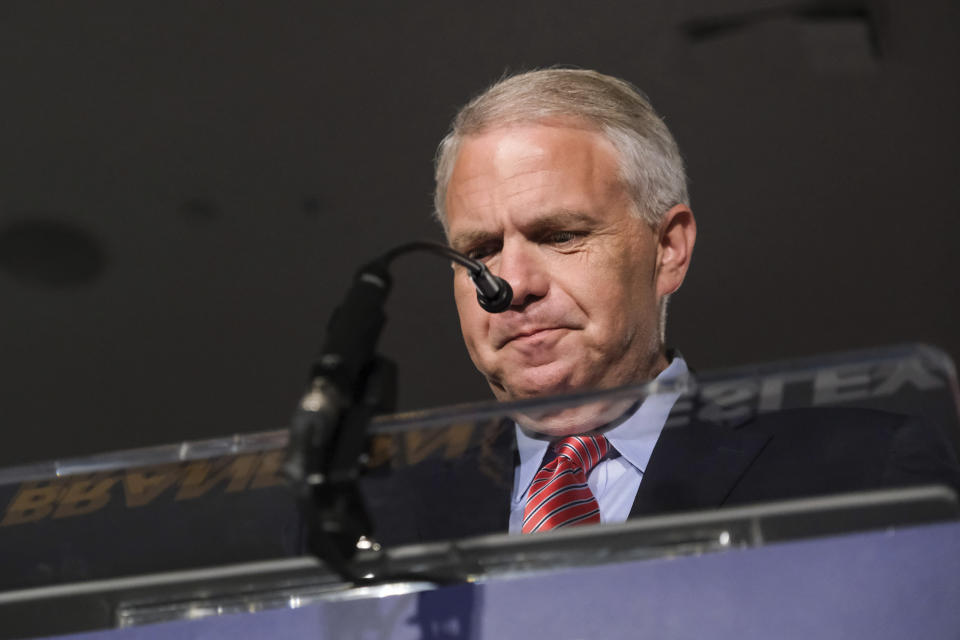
left=446, top=123, right=665, bottom=424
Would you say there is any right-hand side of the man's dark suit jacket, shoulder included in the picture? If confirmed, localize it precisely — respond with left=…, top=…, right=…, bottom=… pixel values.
left=631, top=409, right=960, bottom=516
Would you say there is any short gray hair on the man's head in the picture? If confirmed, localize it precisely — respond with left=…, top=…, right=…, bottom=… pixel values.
left=433, top=69, right=689, bottom=230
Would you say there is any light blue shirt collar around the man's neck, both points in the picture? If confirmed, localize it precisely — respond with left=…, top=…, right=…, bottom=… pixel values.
left=513, top=353, right=688, bottom=503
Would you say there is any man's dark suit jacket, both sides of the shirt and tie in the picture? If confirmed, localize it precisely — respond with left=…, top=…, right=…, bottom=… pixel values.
left=366, top=409, right=960, bottom=544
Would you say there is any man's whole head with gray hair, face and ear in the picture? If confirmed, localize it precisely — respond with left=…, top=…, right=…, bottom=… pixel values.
left=436, top=70, right=696, bottom=418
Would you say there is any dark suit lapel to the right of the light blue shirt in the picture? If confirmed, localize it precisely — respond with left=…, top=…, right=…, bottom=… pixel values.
left=630, top=410, right=770, bottom=517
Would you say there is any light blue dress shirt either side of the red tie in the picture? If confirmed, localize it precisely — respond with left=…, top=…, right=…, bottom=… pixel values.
left=510, top=355, right=687, bottom=533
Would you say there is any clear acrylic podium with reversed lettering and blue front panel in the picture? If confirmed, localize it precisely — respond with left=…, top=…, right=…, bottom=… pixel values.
left=0, top=345, right=960, bottom=640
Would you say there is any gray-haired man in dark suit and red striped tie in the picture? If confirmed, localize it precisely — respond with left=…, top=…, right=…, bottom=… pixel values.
left=400, top=69, right=960, bottom=537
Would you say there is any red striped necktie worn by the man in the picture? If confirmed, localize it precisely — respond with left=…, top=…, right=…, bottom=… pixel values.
left=523, top=436, right=609, bottom=533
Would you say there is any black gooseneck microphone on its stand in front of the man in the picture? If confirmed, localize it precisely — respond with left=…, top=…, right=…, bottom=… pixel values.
left=284, top=241, right=513, bottom=583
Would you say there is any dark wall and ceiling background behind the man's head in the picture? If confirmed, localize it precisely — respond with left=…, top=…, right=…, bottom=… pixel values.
left=0, top=0, right=960, bottom=464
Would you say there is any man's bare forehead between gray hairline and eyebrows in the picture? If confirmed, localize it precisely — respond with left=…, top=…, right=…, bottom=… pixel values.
left=445, top=123, right=626, bottom=234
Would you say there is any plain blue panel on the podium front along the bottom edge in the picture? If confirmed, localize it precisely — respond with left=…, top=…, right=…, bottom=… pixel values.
left=52, top=522, right=960, bottom=640
